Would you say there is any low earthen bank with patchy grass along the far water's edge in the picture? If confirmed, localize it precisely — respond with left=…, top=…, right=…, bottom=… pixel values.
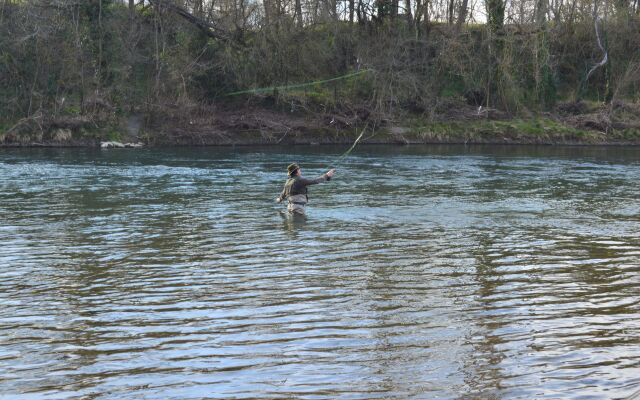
left=0, top=108, right=640, bottom=147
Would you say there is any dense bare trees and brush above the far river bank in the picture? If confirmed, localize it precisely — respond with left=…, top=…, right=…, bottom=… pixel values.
left=0, top=0, right=640, bottom=137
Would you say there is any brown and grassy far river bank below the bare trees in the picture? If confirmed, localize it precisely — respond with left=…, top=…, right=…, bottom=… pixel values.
left=0, top=103, right=640, bottom=147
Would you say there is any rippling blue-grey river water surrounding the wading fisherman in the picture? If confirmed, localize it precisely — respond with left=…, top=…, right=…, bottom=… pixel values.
left=0, top=146, right=640, bottom=399
